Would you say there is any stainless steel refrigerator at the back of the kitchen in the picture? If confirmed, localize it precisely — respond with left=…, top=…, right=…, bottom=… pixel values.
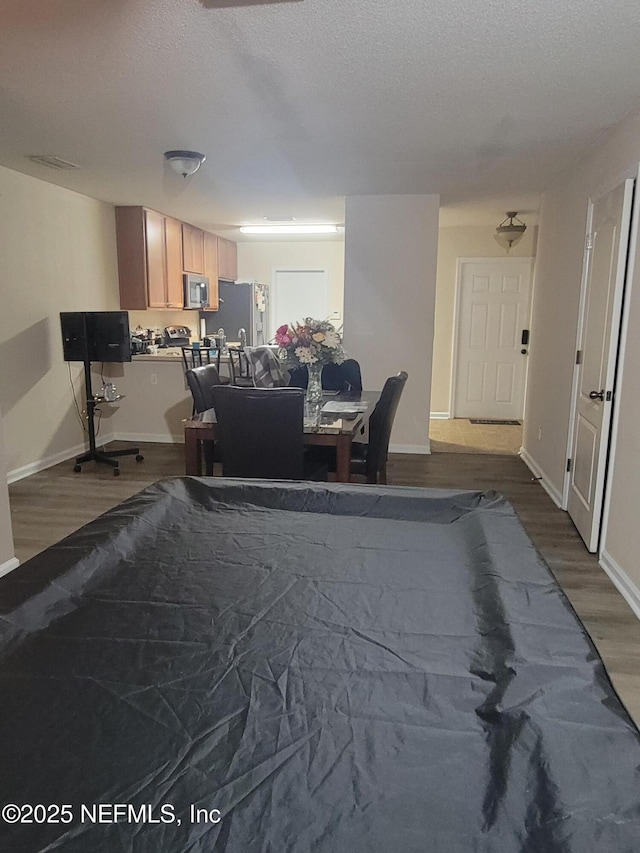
left=200, top=281, right=269, bottom=347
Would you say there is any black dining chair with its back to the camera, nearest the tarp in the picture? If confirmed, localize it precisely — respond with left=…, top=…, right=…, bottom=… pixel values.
left=213, top=385, right=327, bottom=480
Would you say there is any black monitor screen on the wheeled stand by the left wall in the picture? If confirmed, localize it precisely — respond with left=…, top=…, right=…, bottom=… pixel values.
left=60, top=311, right=131, bottom=362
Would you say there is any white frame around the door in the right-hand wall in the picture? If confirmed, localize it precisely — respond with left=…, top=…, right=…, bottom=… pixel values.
left=561, top=170, right=640, bottom=553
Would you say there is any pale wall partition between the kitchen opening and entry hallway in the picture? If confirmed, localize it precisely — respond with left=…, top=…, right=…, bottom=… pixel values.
left=344, top=190, right=439, bottom=453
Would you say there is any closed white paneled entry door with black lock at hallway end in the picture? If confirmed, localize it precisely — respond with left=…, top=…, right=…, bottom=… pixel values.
left=452, top=258, right=532, bottom=420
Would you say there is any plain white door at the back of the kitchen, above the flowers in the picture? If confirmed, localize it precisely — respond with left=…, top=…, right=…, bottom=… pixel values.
left=270, top=269, right=329, bottom=337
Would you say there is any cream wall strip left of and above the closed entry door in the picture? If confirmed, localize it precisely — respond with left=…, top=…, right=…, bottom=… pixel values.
left=431, top=225, right=537, bottom=414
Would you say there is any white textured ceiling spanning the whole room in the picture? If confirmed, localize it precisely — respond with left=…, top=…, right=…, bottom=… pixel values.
left=0, top=0, right=640, bottom=236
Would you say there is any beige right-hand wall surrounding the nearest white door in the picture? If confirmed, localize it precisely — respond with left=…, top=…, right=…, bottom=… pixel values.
left=523, top=100, right=640, bottom=604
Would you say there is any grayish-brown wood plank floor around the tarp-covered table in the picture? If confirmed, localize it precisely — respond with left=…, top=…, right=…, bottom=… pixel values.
left=9, top=442, right=640, bottom=723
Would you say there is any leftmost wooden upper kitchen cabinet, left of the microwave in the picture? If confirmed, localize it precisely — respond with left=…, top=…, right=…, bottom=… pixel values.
left=116, top=207, right=184, bottom=311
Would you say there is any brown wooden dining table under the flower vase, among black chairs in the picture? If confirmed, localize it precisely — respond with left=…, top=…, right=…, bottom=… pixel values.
left=183, top=391, right=380, bottom=483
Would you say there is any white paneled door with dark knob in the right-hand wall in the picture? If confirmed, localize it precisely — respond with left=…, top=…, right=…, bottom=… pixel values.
left=567, top=180, right=634, bottom=551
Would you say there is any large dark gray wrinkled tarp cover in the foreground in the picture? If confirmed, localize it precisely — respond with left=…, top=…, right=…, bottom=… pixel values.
left=0, top=478, right=640, bottom=853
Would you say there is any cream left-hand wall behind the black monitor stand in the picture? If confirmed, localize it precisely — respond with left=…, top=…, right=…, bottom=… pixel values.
left=0, top=168, right=119, bottom=471
